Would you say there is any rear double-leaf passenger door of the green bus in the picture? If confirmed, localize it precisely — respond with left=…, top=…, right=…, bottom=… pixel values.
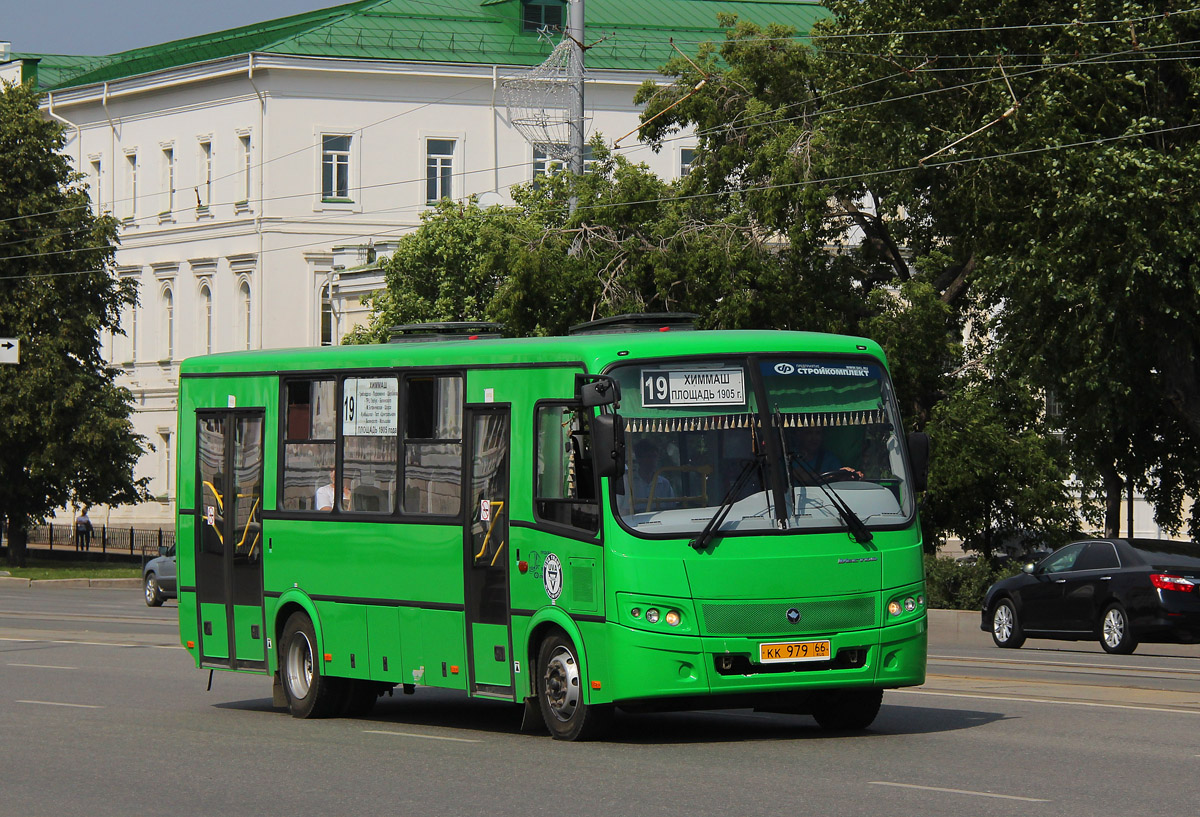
left=196, top=410, right=266, bottom=669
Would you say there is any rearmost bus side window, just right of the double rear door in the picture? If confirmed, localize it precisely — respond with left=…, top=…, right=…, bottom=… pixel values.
left=283, top=380, right=337, bottom=511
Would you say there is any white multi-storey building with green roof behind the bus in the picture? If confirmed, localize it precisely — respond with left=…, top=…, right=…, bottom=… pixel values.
left=0, top=0, right=824, bottom=525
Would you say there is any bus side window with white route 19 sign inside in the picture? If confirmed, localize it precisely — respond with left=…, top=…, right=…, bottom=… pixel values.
left=341, top=377, right=400, bottom=513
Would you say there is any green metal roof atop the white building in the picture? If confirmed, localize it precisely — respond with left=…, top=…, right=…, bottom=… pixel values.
left=25, top=0, right=827, bottom=90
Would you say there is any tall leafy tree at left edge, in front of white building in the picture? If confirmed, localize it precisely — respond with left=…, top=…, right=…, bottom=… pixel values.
left=0, top=84, right=149, bottom=565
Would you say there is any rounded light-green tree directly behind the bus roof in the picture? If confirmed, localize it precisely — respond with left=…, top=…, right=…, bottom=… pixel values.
left=355, top=140, right=782, bottom=341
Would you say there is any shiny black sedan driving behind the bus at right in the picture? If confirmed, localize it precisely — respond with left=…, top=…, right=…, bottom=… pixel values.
left=980, top=539, right=1200, bottom=655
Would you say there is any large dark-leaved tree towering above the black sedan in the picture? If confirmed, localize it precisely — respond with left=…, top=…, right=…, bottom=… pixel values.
left=642, top=0, right=1200, bottom=542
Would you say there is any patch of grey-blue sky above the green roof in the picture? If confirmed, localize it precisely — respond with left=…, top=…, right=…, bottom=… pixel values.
left=0, top=0, right=349, bottom=56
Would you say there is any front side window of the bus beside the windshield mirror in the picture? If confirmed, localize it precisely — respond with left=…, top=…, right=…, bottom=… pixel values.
left=536, top=406, right=600, bottom=533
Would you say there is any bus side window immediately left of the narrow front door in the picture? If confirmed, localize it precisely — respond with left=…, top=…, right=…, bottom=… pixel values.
left=403, top=376, right=463, bottom=516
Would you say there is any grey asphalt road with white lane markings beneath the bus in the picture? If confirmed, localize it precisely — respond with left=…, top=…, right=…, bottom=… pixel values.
left=0, top=587, right=1200, bottom=817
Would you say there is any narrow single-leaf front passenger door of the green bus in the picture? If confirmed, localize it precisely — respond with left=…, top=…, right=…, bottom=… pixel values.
left=463, top=407, right=514, bottom=697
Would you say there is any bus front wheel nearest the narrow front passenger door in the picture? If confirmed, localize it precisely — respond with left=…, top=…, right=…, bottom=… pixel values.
left=538, top=632, right=612, bottom=740
